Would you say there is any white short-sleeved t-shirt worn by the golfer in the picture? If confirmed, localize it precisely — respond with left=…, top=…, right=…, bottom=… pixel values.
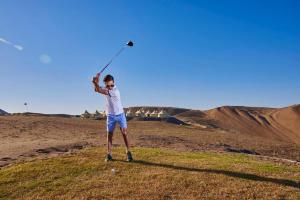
left=104, top=86, right=124, bottom=115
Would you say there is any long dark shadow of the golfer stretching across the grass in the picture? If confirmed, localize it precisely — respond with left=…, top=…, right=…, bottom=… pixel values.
left=116, top=160, right=300, bottom=189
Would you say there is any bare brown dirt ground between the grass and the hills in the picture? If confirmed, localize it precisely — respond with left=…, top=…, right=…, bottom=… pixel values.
left=0, top=116, right=300, bottom=166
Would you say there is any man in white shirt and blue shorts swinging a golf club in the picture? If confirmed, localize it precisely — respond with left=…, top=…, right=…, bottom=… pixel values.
left=93, top=73, right=133, bottom=162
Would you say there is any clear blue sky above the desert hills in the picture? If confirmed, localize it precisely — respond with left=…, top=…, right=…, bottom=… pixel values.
left=0, top=0, right=300, bottom=114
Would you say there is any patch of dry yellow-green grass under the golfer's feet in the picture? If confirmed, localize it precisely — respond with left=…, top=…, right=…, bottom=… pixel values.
left=0, top=148, right=300, bottom=199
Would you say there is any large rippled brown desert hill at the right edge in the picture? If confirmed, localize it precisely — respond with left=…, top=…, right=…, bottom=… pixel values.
left=176, top=105, right=300, bottom=143
